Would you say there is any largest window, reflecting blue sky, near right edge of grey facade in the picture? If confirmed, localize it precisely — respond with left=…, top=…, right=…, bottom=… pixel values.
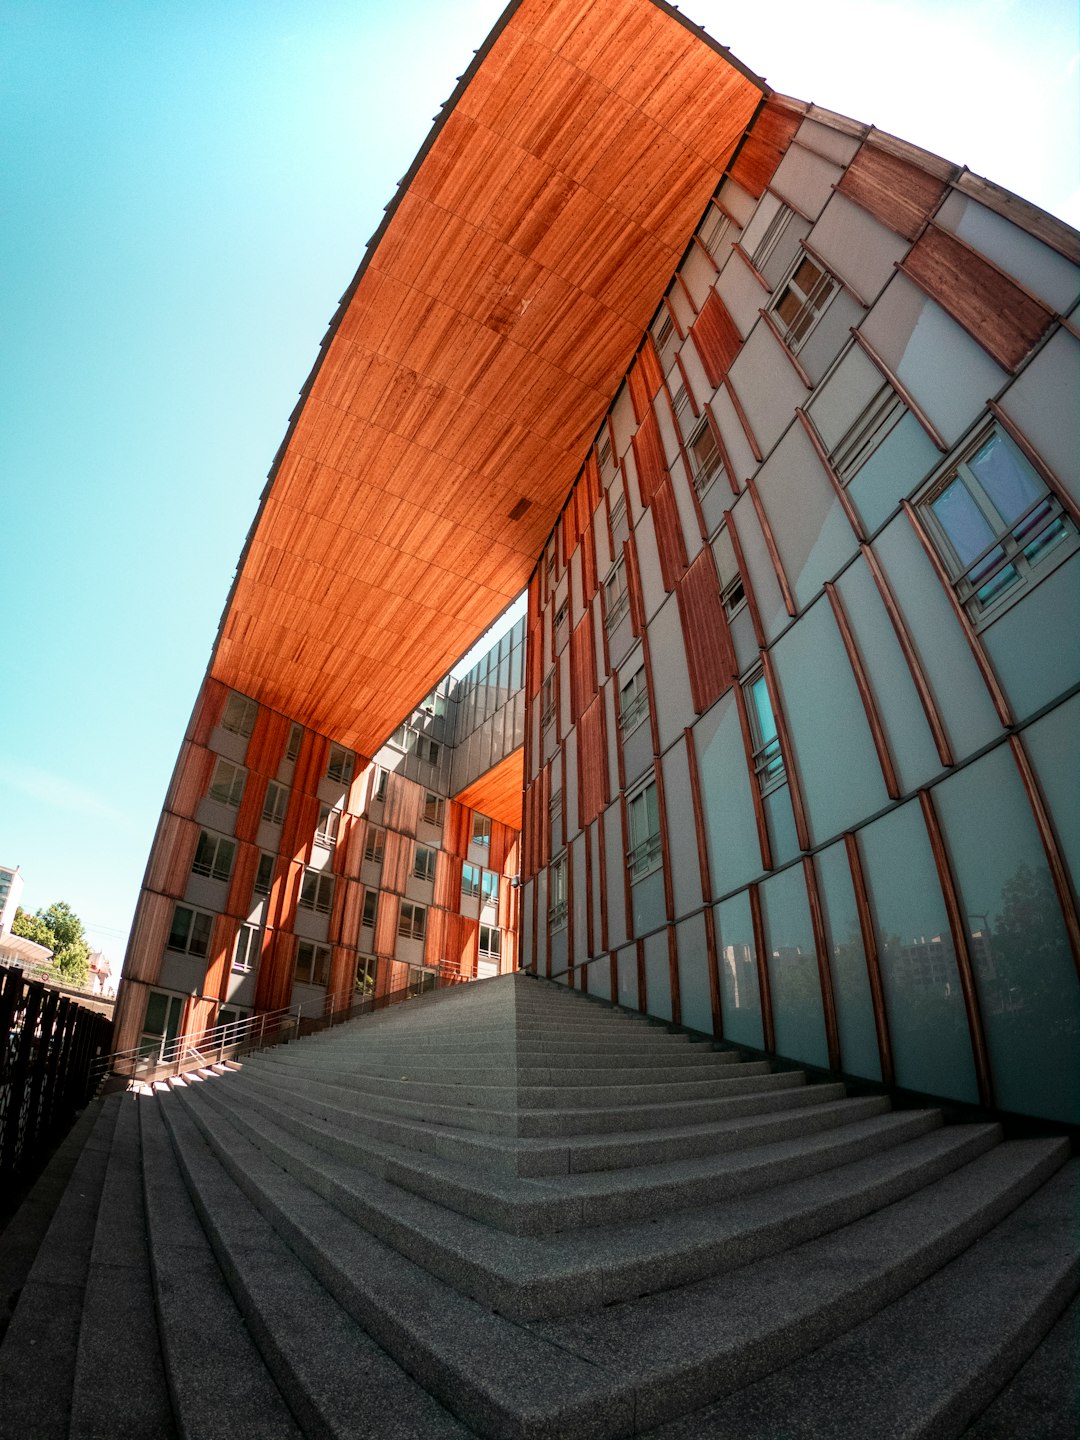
left=920, top=426, right=1076, bottom=630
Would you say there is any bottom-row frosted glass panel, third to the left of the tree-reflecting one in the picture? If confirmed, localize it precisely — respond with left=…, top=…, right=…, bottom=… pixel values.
left=760, top=865, right=829, bottom=1067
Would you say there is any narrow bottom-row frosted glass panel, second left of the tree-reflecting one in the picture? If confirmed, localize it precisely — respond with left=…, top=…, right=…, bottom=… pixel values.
left=814, top=844, right=881, bottom=1080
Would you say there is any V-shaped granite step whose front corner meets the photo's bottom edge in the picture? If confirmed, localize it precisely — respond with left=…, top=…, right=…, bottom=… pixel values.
left=160, top=1092, right=1067, bottom=1440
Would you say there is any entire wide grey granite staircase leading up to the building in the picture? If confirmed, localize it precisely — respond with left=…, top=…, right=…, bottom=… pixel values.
left=0, top=976, right=1080, bottom=1440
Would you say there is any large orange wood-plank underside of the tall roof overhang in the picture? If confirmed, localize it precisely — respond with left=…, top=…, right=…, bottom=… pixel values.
left=210, top=0, right=763, bottom=755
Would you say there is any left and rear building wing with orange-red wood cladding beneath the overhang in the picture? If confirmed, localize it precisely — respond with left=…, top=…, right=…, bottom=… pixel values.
left=117, top=619, right=526, bottom=1048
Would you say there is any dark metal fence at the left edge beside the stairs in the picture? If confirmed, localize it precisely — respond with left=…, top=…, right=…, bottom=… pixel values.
left=0, top=966, right=112, bottom=1181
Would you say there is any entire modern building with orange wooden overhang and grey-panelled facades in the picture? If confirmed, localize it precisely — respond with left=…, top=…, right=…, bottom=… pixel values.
left=117, top=0, right=1080, bottom=1122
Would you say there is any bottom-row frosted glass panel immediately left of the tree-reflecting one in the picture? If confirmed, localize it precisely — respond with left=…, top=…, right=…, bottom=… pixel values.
left=858, top=801, right=979, bottom=1103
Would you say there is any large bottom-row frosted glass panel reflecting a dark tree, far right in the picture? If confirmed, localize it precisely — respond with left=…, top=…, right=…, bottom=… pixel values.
left=933, top=746, right=1080, bottom=1125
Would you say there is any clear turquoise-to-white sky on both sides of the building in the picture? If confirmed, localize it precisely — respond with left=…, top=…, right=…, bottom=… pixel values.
left=0, top=0, right=1080, bottom=969
